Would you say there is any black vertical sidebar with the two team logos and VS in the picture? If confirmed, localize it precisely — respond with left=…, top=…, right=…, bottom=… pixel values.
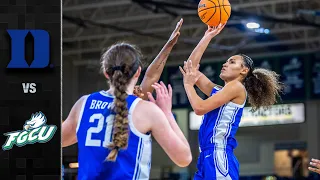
left=0, top=0, right=62, bottom=180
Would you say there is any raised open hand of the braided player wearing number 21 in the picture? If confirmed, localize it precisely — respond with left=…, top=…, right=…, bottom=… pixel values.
left=148, top=81, right=172, bottom=112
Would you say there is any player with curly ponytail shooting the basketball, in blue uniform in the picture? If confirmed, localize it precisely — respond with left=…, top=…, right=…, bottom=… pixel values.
left=179, top=25, right=283, bottom=180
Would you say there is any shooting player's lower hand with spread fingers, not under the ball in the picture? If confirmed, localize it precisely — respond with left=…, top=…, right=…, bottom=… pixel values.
left=179, top=60, right=201, bottom=86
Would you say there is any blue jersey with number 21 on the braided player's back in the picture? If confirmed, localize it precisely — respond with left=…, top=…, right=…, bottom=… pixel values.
left=77, top=91, right=152, bottom=180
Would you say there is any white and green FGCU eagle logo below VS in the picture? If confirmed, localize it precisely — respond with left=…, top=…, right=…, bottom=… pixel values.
left=2, top=111, right=57, bottom=150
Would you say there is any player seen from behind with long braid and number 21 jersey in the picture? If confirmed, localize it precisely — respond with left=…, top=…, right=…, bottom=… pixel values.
left=62, top=20, right=192, bottom=180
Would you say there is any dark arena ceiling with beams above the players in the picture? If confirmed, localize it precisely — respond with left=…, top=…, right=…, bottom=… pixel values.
left=63, top=0, right=320, bottom=65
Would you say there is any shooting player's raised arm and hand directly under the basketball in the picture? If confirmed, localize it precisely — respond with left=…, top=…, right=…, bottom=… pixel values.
left=189, top=24, right=225, bottom=96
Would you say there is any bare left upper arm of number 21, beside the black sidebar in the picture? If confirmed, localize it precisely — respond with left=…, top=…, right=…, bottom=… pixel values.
left=61, top=96, right=87, bottom=147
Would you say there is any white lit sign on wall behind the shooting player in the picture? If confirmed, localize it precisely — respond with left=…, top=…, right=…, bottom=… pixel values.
left=189, top=103, right=305, bottom=130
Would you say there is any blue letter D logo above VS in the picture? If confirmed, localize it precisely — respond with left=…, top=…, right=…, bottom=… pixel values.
left=7, top=30, right=50, bottom=69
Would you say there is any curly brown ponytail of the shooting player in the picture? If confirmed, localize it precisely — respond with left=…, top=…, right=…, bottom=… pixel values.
left=240, top=54, right=284, bottom=112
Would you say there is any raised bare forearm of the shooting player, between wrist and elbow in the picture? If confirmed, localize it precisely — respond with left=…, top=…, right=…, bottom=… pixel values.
left=188, top=36, right=212, bottom=67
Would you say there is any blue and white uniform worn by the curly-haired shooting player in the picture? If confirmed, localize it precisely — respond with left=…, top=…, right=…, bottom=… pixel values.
left=194, top=86, right=245, bottom=180
